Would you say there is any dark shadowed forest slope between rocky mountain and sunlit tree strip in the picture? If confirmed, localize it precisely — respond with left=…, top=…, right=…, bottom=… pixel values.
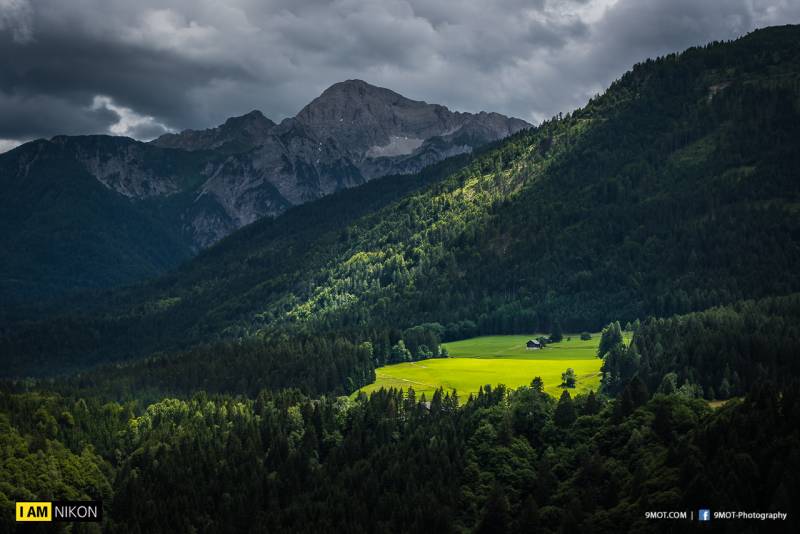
left=0, top=148, right=476, bottom=375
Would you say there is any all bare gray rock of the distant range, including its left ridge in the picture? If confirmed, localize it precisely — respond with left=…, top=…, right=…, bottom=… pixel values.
left=7, top=80, right=530, bottom=250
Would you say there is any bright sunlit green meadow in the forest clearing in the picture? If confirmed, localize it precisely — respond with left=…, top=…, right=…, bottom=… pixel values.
left=361, top=334, right=602, bottom=399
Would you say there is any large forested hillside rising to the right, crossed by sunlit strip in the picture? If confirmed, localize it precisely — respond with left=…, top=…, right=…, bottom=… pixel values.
left=0, top=26, right=800, bottom=376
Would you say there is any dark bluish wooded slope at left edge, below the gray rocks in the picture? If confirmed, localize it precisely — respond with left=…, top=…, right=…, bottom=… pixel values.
left=0, top=136, right=201, bottom=306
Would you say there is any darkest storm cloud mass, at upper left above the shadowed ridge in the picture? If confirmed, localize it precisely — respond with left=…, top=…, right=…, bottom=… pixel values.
left=0, top=0, right=252, bottom=137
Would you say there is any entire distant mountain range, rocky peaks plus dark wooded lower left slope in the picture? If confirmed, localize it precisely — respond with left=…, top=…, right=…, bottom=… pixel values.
left=0, top=80, right=530, bottom=302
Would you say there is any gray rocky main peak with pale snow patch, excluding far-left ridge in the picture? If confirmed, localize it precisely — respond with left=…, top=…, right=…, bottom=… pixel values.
left=152, top=80, right=530, bottom=247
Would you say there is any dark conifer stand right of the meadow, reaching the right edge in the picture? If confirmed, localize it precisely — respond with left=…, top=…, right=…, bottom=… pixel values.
left=628, top=295, right=800, bottom=399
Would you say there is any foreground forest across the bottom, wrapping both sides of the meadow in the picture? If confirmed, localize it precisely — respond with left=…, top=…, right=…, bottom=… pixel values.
left=6, top=296, right=800, bottom=533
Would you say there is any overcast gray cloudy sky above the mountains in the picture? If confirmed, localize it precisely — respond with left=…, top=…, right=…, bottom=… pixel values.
left=0, top=0, right=800, bottom=152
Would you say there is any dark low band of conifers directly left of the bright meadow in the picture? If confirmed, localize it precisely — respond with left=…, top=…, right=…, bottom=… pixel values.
left=57, top=337, right=376, bottom=402
